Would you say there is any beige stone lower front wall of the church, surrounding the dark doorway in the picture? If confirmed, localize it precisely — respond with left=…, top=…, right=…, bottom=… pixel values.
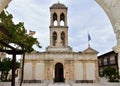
left=24, top=50, right=98, bottom=82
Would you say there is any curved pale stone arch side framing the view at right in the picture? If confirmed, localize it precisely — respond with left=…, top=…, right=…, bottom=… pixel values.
left=96, top=0, right=120, bottom=74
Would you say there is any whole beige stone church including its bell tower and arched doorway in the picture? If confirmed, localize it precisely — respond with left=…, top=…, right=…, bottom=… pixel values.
left=24, top=3, right=98, bottom=82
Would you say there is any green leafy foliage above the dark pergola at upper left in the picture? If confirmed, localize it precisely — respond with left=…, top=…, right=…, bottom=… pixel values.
left=0, top=11, right=41, bottom=52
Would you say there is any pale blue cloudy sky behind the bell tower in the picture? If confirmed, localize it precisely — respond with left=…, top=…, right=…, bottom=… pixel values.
left=7, top=0, right=116, bottom=55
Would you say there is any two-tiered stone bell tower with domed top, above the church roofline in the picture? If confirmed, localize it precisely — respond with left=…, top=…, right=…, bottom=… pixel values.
left=47, top=2, right=72, bottom=52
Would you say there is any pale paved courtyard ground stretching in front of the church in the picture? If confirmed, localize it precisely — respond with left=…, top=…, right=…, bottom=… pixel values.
left=0, top=78, right=120, bottom=86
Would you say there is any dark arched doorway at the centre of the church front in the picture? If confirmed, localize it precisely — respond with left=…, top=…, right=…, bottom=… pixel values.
left=54, top=63, right=64, bottom=82
